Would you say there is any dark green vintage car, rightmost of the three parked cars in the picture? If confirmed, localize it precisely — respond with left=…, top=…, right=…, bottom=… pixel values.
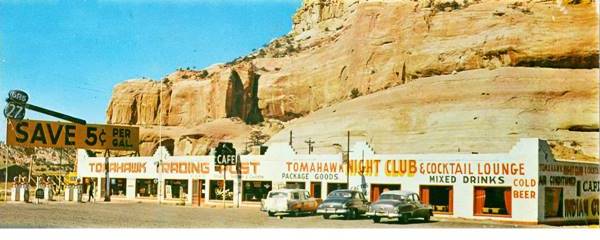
left=366, top=191, right=433, bottom=223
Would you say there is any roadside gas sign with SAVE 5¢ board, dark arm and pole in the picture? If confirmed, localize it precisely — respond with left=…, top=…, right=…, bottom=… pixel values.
left=4, top=90, right=139, bottom=201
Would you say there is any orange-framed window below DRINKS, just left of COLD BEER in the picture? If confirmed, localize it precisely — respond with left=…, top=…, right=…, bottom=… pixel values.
left=473, top=187, right=512, bottom=215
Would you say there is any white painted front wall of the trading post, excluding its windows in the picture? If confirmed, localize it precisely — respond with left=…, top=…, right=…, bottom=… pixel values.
left=77, top=138, right=598, bottom=222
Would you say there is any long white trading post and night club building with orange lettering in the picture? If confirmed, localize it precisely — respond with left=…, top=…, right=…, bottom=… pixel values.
left=77, top=138, right=600, bottom=224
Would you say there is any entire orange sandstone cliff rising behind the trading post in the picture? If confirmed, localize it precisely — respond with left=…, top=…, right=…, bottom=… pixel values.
left=107, top=0, right=599, bottom=159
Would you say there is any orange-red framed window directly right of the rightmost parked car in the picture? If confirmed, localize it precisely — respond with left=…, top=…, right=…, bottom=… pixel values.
left=420, top=186, right=454, bottom=213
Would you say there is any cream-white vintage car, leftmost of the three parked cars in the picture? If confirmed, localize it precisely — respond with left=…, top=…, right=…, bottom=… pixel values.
left=261, top=189, right=322, bottom=216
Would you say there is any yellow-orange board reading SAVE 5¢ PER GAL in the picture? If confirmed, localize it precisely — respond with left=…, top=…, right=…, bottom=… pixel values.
left=6, top=120, right=140, bottom=151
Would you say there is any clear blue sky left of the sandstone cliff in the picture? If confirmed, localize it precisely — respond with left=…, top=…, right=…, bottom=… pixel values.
left=0, top=0, right=301, bottom=140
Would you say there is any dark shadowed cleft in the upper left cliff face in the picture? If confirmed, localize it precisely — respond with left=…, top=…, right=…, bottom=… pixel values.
left=225, top=69, right=264, bottom=124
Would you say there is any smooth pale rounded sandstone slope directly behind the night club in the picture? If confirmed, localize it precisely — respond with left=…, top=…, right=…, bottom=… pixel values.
left=270, top=67, right=600, bottom=160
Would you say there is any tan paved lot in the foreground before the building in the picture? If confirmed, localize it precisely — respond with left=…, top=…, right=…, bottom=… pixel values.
left=0, top=202, right=550, bottom=228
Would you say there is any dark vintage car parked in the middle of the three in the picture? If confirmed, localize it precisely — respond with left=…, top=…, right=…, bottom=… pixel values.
left=317, top=190, right=370, bottom=219
